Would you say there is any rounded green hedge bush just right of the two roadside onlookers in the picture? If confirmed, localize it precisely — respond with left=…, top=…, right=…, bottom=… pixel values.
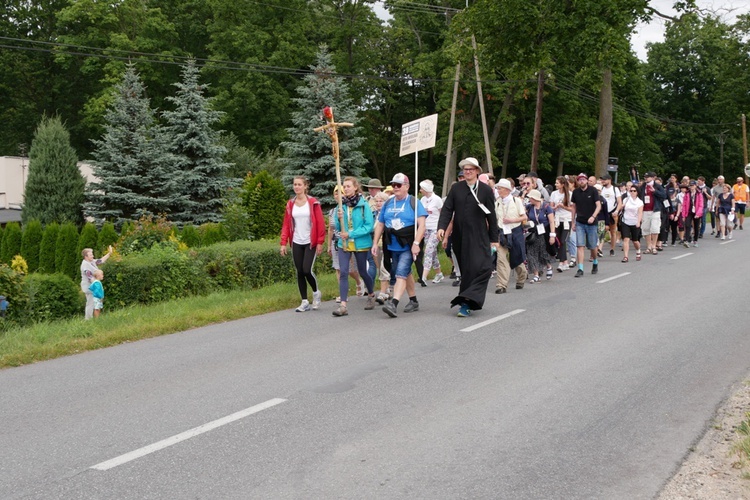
left=103, top=245, right=213, bottom=308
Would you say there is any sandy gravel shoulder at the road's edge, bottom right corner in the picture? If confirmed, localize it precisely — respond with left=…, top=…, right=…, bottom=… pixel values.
left=657, top=382, right=750, bottom=500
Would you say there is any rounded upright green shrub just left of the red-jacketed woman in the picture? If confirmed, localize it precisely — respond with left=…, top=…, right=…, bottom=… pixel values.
left=242, top=170, right=287, bottom=239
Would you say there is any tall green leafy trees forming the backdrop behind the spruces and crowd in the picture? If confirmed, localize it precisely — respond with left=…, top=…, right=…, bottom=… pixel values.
left=0, top=0, right=750, bottom=193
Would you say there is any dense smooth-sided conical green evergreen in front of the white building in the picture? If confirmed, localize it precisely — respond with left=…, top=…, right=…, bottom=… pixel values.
left=21, top=116, right=86, bottom=224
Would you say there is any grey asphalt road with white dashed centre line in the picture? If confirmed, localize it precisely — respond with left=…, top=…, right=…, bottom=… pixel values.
left=0, top=231, right=750, bottom=499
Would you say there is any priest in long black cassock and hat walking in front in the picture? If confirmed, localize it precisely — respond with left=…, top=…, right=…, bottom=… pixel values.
left=437, top=157, right=498, bottom=317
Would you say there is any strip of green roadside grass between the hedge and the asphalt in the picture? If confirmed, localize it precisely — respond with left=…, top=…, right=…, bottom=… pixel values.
left=0, top=253, right=458, bottom=368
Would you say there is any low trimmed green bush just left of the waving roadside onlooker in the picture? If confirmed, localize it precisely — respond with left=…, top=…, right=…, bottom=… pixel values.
left=26, top=273, right=86, bottom=322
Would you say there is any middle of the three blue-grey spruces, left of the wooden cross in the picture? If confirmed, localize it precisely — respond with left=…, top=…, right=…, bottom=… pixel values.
left=162, top=60, right=239, bottom=224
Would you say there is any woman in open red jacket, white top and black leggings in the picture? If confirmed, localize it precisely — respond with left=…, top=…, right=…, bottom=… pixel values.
left=281, top=176, right=326, bottom=312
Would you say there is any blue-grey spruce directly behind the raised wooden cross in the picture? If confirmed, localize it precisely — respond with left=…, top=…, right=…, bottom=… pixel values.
left=281, top=46, right=367, bottom=204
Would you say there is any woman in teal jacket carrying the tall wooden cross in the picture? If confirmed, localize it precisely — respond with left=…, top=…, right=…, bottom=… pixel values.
left=333, top=177, right=375, bottom=317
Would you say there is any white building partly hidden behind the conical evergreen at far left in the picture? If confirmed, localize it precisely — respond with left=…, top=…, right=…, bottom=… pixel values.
left=0, top=156, right=96, bottom=225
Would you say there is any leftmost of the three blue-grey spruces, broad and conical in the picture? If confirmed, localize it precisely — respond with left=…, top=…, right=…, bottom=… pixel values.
left=85, top=64, right=177, bottom=226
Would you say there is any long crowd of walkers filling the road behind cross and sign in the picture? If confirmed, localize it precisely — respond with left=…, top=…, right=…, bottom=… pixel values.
left=281, top=166, right=750, bottom=318
